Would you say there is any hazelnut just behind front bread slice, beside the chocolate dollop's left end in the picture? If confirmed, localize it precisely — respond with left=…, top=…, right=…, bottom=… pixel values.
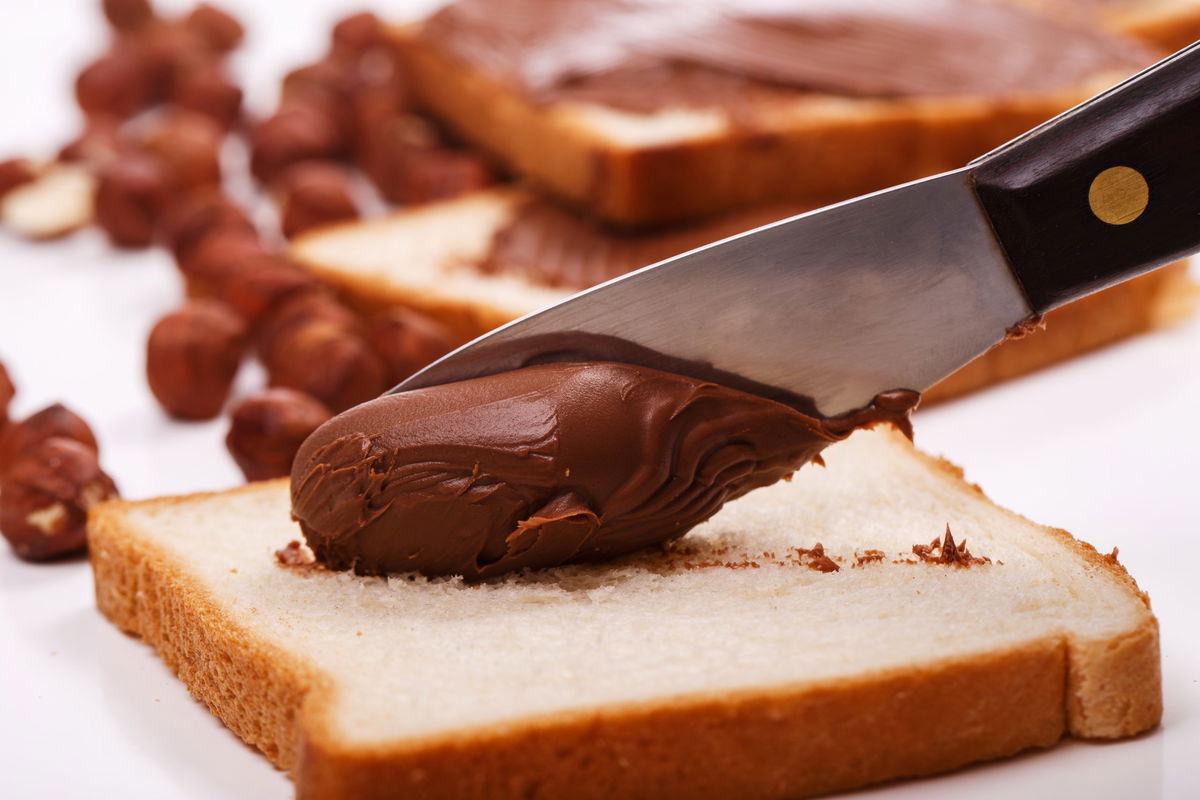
left=226, top=389, right=332, bottom=481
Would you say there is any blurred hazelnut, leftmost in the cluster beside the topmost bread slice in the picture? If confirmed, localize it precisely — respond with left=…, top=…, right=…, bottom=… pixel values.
left=250, top=103, right=343, bottom=184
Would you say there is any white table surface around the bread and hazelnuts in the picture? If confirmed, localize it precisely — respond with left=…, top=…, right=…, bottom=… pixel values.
left=0, top=0, right=1200, bottom=800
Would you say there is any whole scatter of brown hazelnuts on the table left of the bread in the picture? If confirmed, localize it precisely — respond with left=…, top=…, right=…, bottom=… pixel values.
left=0, top=0, right=494, bottom=560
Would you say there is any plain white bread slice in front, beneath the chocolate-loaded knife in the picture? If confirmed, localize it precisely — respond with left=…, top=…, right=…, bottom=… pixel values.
left=90, top=431, right=1162, bottom=800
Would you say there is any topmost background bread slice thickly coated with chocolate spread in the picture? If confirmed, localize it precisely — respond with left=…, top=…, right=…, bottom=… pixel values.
left=394, top=0, right=1159, bottom=227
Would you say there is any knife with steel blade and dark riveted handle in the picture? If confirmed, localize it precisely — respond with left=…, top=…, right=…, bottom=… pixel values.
left=391, top=42, right=1200, bottom=416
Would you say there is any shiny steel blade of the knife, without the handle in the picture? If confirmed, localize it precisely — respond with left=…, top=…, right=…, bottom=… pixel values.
left=392, top=169, right=1030, bottom=416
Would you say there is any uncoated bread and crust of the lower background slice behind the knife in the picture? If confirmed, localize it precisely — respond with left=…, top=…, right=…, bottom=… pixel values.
left=292, top=188, right=1196, bottom=403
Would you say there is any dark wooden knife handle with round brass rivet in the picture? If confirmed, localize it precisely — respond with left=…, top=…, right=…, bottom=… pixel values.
left=972, top=42, right=1200, bottom=313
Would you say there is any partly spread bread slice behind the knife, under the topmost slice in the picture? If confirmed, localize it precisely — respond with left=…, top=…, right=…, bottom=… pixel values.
left=292, top=188, right=1198, bottom=403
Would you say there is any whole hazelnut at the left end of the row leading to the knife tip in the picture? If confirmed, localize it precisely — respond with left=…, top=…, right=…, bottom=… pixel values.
left=146, top=300, right=246, bottom=420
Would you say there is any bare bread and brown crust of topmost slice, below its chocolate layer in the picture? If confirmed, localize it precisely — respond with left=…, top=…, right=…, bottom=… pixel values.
left=392, top=15, right=1153, bottom=227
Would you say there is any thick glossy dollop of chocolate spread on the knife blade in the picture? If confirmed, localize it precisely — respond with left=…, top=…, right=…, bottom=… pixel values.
left=292, top=362, right=917, bottom=581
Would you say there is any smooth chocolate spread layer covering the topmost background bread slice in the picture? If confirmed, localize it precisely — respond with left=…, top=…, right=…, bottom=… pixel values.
left=418, top=0, right=1154, bottom=112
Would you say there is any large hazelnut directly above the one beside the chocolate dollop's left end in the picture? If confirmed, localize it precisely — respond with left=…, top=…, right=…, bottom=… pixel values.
left=266, top=320, right=385, bottom=413
